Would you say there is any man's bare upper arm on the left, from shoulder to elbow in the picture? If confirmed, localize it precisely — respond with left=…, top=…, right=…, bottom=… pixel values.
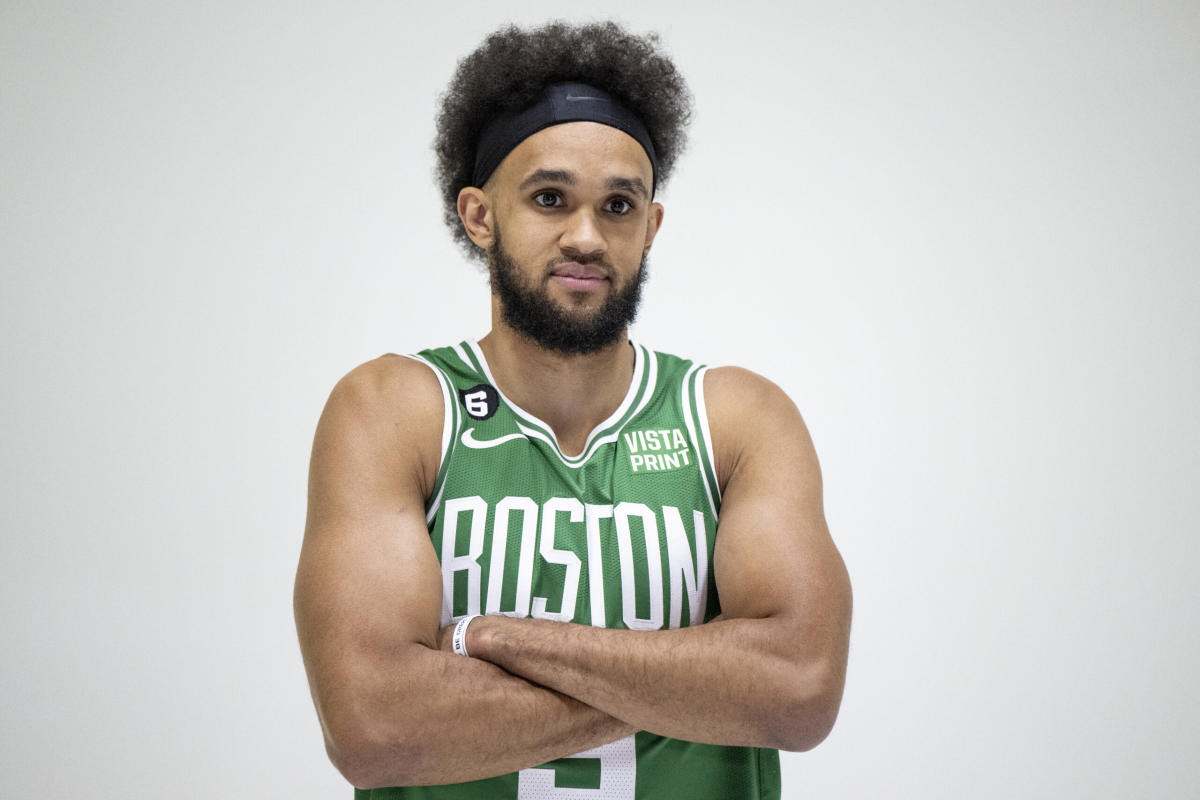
left=294, top=362, right=442, bottom=718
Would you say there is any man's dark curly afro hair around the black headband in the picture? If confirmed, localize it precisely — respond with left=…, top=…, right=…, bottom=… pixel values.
left=433, top=22, right=691, bottom=260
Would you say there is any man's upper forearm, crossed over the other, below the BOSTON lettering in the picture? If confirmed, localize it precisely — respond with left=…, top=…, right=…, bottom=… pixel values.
left=469, top=616, right=841, bottom=750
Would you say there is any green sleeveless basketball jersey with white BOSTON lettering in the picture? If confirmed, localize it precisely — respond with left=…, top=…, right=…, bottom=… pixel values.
left=355, top=342, right=780, bottom=800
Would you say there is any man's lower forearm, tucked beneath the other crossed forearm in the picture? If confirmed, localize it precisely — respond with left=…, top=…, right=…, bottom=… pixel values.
left=331, top=645, right=634, bottom=788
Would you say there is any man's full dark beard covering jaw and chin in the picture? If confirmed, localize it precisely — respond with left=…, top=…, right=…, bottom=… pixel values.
left=487, top=228, right=646, bottom=355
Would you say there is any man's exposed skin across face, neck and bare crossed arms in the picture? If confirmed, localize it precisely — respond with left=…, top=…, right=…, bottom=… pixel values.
left=295, top=122, right=851, bottom=787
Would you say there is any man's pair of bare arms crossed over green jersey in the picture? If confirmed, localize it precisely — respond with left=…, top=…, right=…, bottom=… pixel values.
left=295, top=357, right=850, bottom=787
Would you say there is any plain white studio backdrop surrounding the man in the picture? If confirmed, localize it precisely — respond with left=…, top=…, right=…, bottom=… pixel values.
left=0, top=0, right=1200, bottom=799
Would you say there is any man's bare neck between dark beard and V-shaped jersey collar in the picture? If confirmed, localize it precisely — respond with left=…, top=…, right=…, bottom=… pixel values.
left=479, top=320, right=634, bottom=456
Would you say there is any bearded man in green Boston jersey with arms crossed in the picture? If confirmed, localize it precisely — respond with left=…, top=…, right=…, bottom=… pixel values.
left=295, top=18, right=850, bottom=800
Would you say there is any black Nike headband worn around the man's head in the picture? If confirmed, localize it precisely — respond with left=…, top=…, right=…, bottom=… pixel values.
left=472, top=83, right=659, bottom=194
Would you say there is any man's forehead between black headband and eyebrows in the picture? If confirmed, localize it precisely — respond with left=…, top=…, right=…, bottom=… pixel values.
left=496, top=122, right=654, bottom=186
